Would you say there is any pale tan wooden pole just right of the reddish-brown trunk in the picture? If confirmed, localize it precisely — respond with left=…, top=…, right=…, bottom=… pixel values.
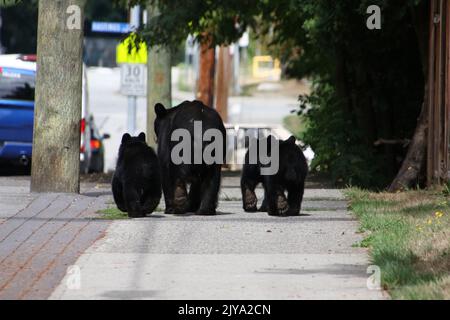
left=216, top=46, right=231, bottom=122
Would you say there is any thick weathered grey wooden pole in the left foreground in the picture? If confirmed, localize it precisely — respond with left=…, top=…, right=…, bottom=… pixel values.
left=31, top=0, right=85, bottom=193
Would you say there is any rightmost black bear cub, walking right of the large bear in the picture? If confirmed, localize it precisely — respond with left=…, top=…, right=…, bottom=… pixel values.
left=241, top=136, right=308, bottom=216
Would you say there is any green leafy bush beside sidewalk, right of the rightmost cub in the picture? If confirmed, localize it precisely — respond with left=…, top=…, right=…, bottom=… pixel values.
left=301, top=84, right=388, bottom=187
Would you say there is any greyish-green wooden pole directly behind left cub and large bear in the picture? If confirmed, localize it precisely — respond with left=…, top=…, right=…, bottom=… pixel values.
left=147, top=4, right=172, bottom=147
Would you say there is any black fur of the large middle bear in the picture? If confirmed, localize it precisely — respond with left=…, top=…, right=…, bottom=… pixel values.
left=155, top=101, right=226, bottom=215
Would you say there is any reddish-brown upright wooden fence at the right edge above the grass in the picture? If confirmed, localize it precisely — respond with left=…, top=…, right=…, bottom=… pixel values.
left=427, top=0, right=450, bottom=186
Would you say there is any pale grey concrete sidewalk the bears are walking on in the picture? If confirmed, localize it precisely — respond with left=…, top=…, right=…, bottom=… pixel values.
left=51, top=177, right=382, bottom=299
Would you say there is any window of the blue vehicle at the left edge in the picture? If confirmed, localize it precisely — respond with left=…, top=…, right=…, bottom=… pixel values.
left=0, top=67, right=35, bottom=101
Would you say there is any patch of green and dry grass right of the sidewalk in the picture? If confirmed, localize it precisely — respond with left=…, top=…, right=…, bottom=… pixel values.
left=346, top=188, right=450, bottom=299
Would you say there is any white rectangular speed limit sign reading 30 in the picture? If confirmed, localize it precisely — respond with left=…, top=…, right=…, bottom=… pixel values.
left=120, top=63, right=147, bottom=97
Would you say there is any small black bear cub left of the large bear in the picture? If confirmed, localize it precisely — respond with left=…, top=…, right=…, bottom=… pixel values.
left=112, top=132, right=161, bottom=218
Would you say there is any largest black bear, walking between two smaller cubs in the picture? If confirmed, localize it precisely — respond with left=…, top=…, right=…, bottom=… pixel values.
left=155, top=101, right=226, bottom=215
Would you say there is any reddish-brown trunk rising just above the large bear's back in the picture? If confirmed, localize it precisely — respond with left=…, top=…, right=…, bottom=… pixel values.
left=196, top=37, right=215, bottom=108
